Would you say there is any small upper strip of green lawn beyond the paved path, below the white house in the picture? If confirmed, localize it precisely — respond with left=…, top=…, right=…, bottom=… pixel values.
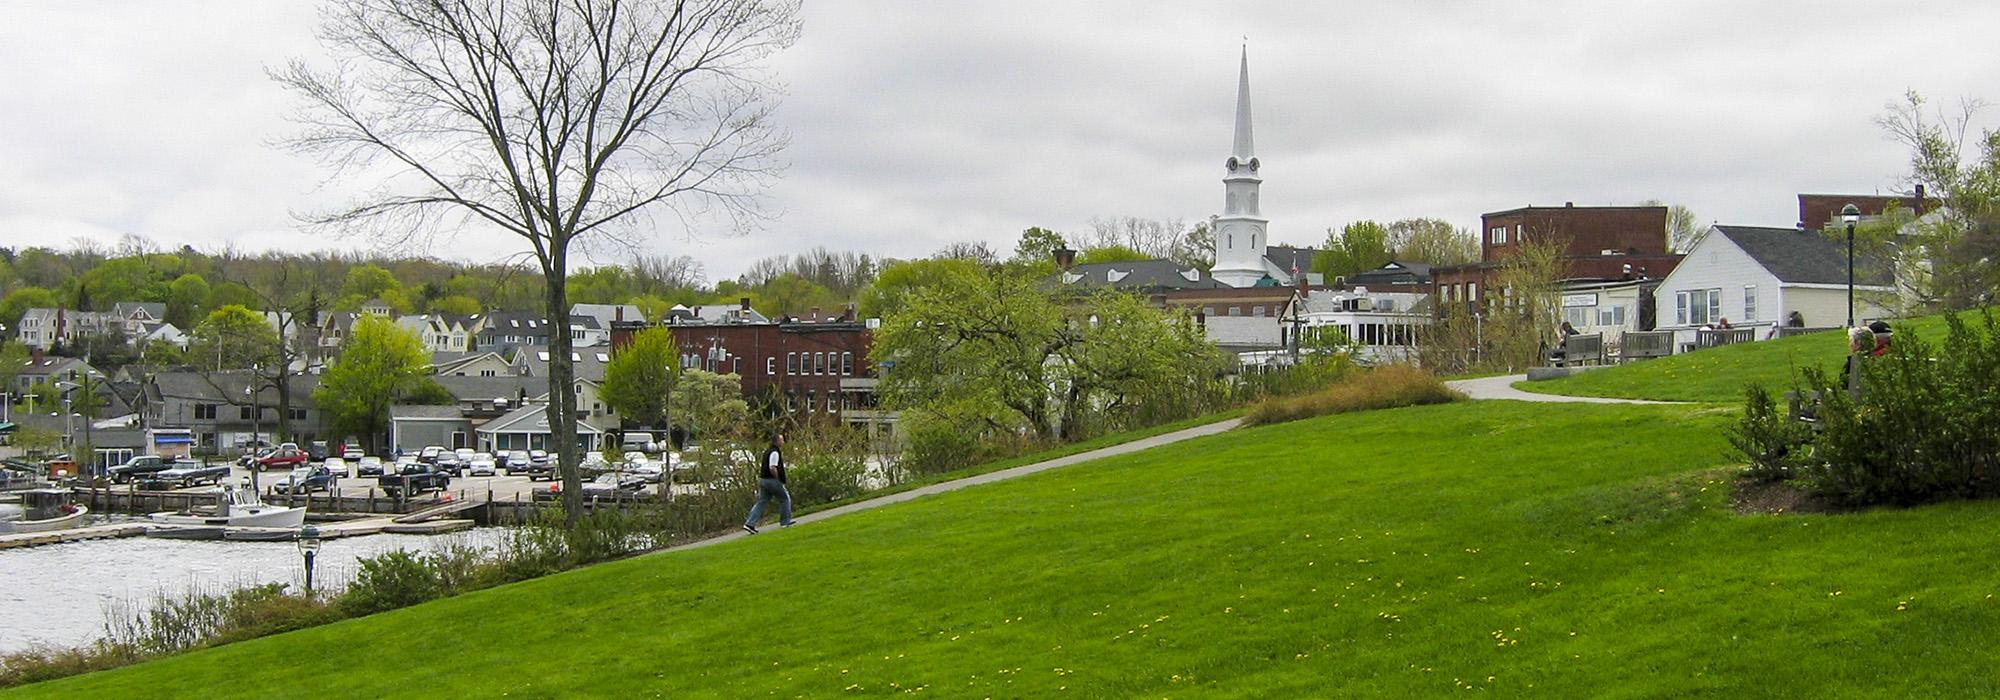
left=1516, top=316, right=1952, bottom=402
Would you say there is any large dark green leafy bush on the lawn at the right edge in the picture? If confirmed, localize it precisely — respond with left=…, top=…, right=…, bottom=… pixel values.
left=1776, top=312, right=2000, bottom=506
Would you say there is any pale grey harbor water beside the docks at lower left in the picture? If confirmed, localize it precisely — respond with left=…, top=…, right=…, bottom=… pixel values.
left=0, top=528, right=506, bottom=654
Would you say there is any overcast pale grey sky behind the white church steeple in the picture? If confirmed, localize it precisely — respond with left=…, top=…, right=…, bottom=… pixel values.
left=0, top=0, right=2000, bottom=278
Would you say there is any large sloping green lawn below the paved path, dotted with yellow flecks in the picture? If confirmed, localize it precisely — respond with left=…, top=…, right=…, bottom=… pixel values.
left=16, top=402, right=2000, bottom=698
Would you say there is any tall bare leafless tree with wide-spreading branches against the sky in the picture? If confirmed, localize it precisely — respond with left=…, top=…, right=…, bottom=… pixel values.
left=274, top=0, right=800, bottom=524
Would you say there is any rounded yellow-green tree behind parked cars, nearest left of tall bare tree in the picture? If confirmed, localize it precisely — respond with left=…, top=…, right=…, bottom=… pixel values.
left=312, top=316, right=430, bottom=450
